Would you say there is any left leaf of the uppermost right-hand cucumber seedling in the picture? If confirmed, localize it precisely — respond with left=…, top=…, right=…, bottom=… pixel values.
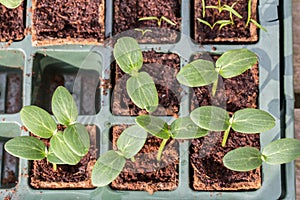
left=176, top=59, right=218, bottom=87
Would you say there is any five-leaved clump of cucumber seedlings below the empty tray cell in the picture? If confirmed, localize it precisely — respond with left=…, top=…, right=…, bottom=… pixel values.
left=4, top=86, right=90, bottom=171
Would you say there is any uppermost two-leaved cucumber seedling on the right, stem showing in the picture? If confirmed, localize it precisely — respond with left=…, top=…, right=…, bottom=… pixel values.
left=176, top=49, right=258, bottom=96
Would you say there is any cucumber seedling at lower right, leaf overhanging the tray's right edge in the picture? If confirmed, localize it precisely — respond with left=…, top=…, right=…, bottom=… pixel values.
left=223, top=138, right=300, bottom=172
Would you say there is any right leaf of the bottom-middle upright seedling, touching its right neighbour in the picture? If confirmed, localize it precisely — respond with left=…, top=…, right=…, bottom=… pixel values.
left=171, top=117, right=208, bottom=139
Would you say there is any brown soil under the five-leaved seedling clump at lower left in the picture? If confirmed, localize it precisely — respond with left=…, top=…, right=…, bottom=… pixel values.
left=30, top=126, right=97, bottom=189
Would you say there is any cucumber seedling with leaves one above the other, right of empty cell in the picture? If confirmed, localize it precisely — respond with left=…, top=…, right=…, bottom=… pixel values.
left=113, top=37, right=158, bottom=112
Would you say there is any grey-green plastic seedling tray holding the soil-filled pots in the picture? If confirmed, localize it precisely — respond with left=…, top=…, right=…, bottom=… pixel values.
left=0, top=0, right=295, bottom=200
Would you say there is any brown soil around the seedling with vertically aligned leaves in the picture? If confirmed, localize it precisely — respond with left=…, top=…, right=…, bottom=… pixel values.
left=112, top=51, right=182, bottom=116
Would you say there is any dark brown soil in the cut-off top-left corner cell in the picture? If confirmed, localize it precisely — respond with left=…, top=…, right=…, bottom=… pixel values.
left=0, top=2, right=25, bottom=42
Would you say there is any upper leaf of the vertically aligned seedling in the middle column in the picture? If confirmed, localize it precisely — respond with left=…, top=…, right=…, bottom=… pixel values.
left=114, top=37, right=143, bottom=74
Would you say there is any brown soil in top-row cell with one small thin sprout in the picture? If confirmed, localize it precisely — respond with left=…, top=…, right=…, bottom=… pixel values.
left=113, top=0, right=181, bottom=43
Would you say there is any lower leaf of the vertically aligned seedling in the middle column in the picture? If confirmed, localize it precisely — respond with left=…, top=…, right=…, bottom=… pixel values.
left=126, top=72, right=158, bottom=112
